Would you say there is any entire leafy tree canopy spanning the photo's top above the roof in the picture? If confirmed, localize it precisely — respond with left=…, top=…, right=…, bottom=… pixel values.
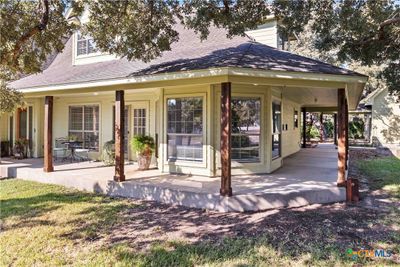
left=0, top=0, right=400, bottom=113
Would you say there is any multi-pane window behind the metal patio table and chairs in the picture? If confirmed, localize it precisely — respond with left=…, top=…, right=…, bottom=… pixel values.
left=68, top=105, right=99, bottom=151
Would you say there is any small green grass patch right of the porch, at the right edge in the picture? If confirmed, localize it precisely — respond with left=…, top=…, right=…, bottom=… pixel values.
left=357, top=157, right=400, bottom=198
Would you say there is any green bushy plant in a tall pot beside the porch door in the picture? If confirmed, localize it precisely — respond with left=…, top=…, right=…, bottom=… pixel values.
left=131, top=135, right=155, bottom=170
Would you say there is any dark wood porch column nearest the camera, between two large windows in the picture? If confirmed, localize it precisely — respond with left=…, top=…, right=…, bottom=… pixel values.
left=220, top=82, right=232, bottom=196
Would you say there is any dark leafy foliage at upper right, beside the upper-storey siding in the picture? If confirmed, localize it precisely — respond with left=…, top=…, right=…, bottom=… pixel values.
left=275, top=0, right=400, bottom=95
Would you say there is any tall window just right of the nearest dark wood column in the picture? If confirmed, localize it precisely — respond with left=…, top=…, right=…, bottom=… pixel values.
left=231, top=97, right=261, bottom=162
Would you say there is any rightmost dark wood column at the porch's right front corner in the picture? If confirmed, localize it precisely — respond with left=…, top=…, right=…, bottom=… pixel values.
left=337, top=88, right=346, bottom=186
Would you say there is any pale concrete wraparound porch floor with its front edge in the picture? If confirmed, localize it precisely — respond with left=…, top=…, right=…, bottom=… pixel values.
left=0, top=144, right=345, bottom=212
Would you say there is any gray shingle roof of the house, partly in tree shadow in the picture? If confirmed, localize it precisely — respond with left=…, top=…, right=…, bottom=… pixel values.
left=11, top=26, right=361, bottom=89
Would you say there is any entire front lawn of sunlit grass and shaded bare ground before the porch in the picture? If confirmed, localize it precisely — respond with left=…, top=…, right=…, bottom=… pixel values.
left=0, top=158, right=400, bottom=266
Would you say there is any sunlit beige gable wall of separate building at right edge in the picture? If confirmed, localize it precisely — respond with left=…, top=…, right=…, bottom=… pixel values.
left=372, top=90, right=400, bottom=145
